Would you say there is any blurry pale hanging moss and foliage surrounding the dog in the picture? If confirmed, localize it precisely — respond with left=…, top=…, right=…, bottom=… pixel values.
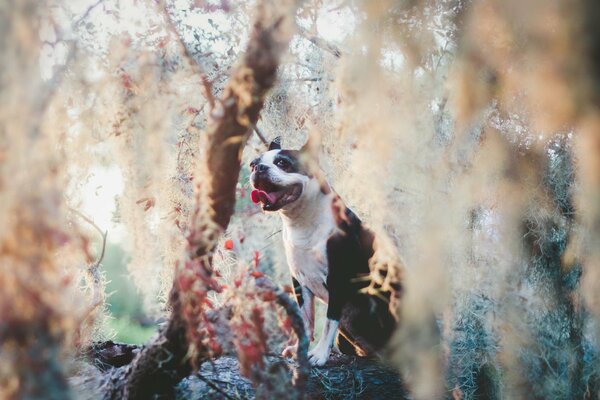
left=0, top=0, right=600, bottom=399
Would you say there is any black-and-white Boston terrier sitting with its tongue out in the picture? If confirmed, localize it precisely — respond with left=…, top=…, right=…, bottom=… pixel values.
left=250, top=138, right=396, bottom=366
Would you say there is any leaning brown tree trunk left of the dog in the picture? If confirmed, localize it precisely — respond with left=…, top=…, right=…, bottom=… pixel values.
left=107, top=2, right=296, bottom=399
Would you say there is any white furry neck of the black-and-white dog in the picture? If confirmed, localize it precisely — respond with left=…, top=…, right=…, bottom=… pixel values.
left=279, top=180, right=333, bottom=239
